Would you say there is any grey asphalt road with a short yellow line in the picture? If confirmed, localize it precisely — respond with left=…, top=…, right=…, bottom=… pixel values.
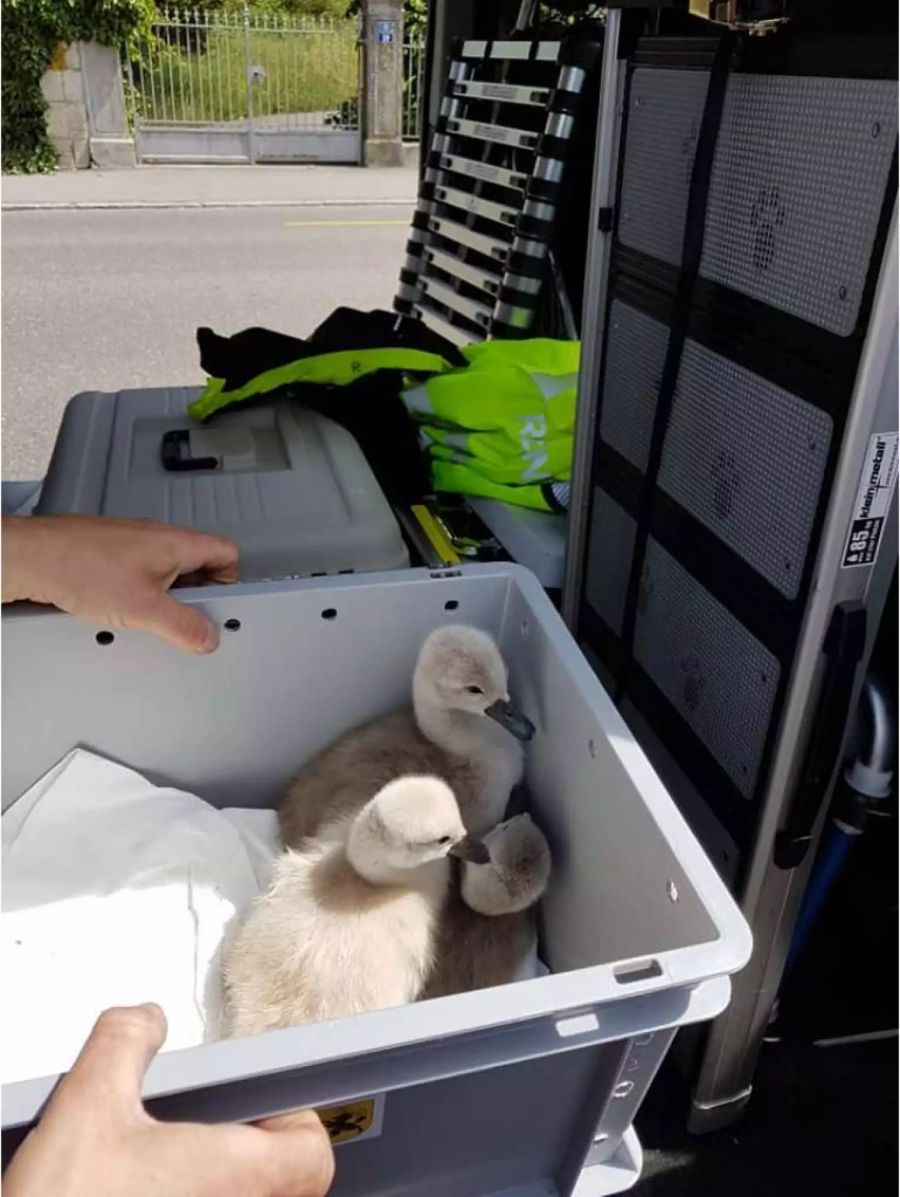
left=1, top=207, right=412, bottom=480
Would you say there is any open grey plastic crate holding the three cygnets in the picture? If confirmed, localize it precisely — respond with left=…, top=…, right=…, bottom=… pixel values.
left=2, top=565, right=750, bottom=1197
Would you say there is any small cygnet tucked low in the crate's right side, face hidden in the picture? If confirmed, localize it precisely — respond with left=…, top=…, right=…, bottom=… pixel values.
left=421, top=814, right=552, bottom=998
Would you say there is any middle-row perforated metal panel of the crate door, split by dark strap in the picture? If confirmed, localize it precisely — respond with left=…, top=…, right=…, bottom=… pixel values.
left=600, top=300, right=832, bottom=599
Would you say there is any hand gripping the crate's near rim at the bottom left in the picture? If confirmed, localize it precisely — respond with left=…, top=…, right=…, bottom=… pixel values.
left=4, top=1005, right=334, bottom=1197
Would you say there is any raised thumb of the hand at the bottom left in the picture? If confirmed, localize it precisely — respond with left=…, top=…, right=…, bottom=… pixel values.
left=47, top=1003, right=166, bottom=1118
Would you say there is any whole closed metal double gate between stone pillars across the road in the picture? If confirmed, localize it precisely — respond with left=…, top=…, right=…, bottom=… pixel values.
left=126, top=5, right=361, bottom=163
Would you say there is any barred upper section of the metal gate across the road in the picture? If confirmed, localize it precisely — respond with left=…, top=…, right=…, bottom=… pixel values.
left=127, top=6, right=360, bottom=130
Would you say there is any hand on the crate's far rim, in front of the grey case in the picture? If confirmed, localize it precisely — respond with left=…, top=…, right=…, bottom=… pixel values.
left=4, top=516, right=238, bottom=652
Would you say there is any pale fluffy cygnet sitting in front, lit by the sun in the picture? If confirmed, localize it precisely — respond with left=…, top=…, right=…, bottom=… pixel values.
left=224, top=777, right=480, bottom=1037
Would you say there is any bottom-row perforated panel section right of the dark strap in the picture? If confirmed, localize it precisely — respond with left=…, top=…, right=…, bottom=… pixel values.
left=634, top=537, right=780, bottom=797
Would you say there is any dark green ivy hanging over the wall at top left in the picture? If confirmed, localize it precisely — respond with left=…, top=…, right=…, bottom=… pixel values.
left=2, top=0, right=156, bottom=174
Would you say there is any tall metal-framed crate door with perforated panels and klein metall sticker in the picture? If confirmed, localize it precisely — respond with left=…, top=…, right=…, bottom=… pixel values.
left=563, top=30, right=898, bottom=1131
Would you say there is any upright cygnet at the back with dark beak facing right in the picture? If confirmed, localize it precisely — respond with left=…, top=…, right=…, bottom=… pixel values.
left=280, top=625, right=534, bottom=847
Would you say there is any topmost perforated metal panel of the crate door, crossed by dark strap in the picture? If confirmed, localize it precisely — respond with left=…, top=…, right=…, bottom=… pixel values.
left=619, top=69, right=898, bottom=336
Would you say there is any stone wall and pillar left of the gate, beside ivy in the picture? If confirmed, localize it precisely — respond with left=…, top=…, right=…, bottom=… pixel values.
left=41, top=42, right=134, bottom=170
